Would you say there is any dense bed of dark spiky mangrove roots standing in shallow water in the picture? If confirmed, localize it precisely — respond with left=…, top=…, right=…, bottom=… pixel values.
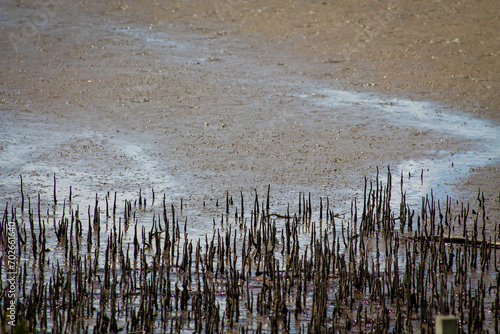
left=0, top=170, right=500, bottom=333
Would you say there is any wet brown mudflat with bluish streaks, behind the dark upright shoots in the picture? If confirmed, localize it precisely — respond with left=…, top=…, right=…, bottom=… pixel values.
left=0, top=0, right=500, bottom=220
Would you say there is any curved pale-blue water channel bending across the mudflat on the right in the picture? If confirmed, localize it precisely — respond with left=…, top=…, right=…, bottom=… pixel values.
left=303, top=90, right=500, bottom=204
